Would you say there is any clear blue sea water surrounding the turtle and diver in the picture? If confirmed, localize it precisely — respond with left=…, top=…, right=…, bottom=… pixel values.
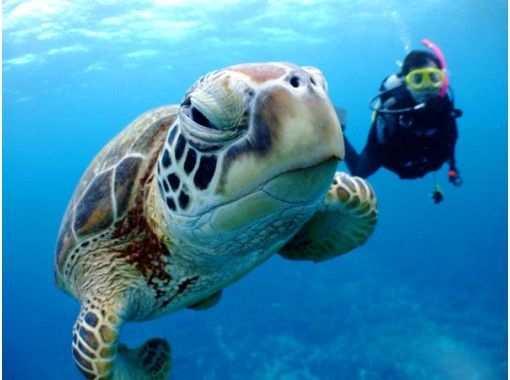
left=2, top=0, right=508, bottom=380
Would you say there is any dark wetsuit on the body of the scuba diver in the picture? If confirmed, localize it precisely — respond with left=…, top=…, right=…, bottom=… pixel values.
left=345, top=78, right=460, bottom=179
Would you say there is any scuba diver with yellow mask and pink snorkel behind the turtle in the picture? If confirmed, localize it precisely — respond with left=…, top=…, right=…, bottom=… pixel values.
left=345, top=39, right=462, bottom=203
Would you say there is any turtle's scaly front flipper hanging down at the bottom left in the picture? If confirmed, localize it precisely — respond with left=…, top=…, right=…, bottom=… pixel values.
left=72, top=302, right=171, bottom=380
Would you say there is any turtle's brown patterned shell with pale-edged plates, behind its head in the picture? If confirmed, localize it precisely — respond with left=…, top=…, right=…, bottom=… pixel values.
left=55, top=106, right=178, bottom=287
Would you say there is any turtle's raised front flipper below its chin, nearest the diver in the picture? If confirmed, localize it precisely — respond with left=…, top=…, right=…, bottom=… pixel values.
left=279, top=172, right=377, bottom=261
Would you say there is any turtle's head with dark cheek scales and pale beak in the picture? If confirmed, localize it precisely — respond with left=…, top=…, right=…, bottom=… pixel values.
left=157, top=63, right=344, bottom=251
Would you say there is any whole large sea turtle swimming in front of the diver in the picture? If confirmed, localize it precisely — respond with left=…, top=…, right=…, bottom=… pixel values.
left=55, top=63, right=377, bottom=379
